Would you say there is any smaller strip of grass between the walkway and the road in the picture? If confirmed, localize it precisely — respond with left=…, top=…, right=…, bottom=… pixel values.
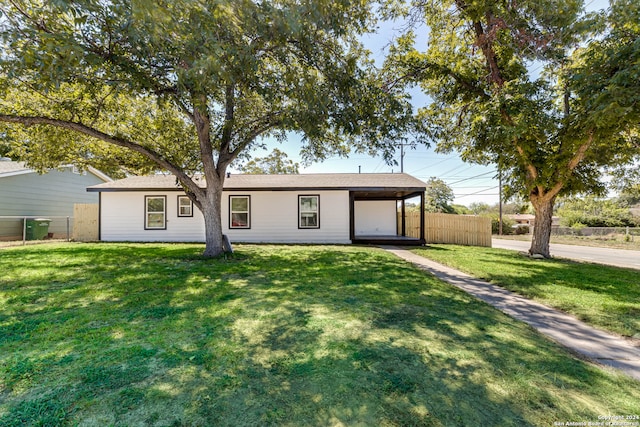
left=414, top=245, right=640, bottom=337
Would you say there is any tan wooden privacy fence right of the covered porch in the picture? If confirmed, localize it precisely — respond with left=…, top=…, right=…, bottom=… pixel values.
left=398, top=212, right=491, bottom=247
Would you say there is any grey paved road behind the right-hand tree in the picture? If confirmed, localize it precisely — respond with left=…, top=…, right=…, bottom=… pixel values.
left=492, top=239, right=640, bottom=270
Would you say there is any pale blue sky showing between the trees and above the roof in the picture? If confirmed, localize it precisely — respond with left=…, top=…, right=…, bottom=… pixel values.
left=230, top=0, right=608, bottom=206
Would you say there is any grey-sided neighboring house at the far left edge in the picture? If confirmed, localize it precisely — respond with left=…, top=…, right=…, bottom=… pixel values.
left=0, top=158, right=111, bottom=240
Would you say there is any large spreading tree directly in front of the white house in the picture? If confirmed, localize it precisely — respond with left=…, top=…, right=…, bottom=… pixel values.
left=0, top=0, right=410, bottom=256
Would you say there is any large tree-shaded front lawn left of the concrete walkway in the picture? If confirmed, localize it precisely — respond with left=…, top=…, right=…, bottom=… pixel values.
left=0, top=244, right=640, bottom=426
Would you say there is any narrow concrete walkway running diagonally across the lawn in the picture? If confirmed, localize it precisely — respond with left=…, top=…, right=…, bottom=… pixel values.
left=382, top=246, right=640, bottom=380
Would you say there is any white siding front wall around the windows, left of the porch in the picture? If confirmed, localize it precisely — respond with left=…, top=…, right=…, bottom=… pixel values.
left=100, top=191, right=350, bottom=243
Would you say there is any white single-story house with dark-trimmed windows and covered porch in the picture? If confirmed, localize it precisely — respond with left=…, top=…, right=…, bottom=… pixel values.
left=87, top=174, right=426, bottom=245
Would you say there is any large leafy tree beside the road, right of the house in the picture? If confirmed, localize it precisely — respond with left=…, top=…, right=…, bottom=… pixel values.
left=388, top=0, right=640, bottom=257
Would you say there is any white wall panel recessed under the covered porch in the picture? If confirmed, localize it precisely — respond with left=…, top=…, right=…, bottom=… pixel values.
left=354, top=200, right=397, bottom=236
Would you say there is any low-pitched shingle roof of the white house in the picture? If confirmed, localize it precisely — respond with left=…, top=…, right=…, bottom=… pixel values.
left=87, top=173, right=426, bottom=197
